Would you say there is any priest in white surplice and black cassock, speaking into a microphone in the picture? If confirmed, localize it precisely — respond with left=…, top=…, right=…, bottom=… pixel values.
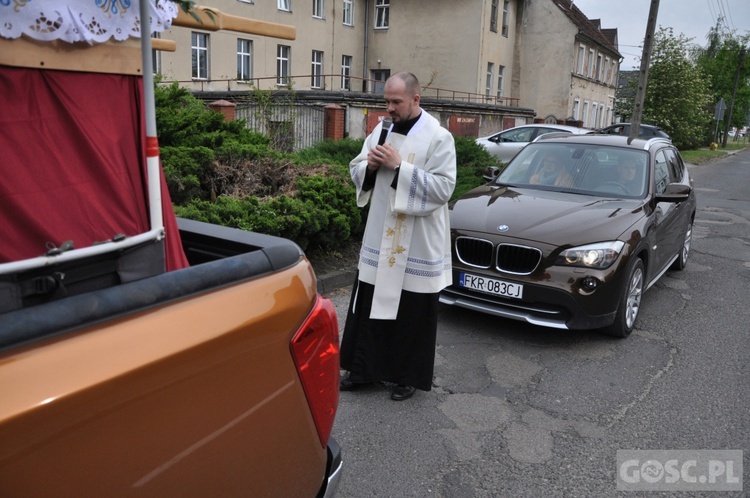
left=340, top=72, right=456, bottom=401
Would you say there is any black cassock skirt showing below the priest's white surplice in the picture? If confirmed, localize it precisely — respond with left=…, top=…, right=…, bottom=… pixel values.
left=341, top=279, right=439, bottom=391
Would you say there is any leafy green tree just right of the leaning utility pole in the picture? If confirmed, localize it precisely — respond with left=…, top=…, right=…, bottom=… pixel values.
left=618, top=27, right=713, bottom=149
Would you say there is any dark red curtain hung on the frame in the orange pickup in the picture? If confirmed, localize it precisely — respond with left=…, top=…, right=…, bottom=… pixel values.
left=0, top=66, right=187, bottom=270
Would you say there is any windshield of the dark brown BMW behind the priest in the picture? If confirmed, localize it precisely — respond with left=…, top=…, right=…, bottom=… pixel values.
left=495, top=143, right=649, bottom=199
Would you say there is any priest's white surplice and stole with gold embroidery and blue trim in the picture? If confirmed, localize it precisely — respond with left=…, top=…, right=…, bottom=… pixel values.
left=349, top=110, right=456, bottom=320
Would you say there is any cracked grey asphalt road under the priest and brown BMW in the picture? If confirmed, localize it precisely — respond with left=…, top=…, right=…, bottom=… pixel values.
left=328, top=151, right=750, bottom=498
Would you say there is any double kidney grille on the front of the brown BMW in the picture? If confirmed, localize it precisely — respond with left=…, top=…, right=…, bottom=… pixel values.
left=456, top=237, right=542, bottom=275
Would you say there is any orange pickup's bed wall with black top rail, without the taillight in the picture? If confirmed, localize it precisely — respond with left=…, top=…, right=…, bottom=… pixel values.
left=0, top=220, right=338, bottom=497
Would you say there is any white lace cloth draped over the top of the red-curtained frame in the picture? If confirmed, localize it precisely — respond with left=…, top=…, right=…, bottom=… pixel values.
left=0, top=0, right=178, bottom=44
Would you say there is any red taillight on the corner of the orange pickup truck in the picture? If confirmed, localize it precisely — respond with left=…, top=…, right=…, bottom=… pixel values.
left=291, top=295, right=339, bottom=448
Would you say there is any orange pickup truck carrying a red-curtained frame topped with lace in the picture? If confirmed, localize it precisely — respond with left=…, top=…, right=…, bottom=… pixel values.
left=0, top=0, right=342, bottom=498
